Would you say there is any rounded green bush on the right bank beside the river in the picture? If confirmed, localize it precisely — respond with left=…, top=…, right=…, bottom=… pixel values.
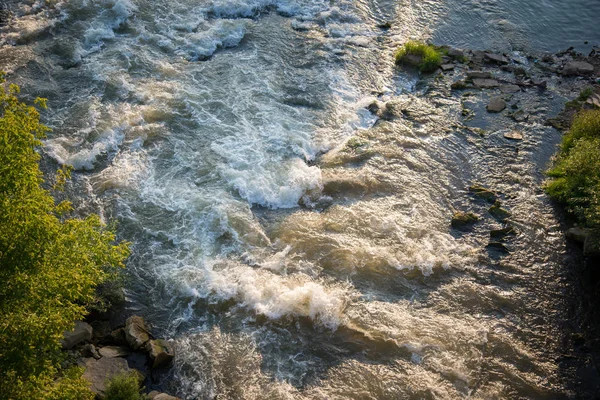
left=546, top=110, right=600, bottom=227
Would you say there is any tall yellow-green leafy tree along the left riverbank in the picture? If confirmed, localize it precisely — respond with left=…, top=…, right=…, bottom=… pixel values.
left=0, top=73, right=129, bottom=400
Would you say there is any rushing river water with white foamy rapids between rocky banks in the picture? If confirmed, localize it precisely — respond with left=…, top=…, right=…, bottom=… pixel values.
left=1, top=0, right=600, bottom=399
